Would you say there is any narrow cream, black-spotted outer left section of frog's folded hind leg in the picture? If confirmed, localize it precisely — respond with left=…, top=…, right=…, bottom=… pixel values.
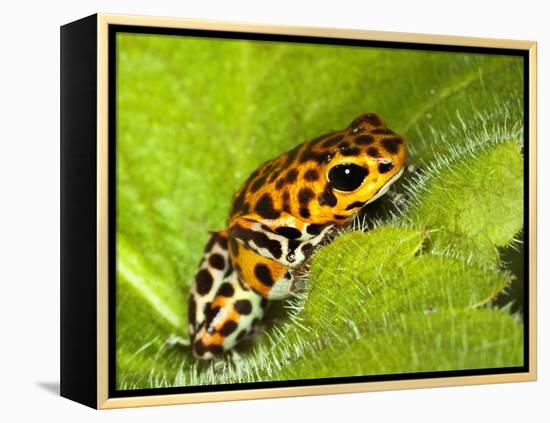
left=187, top=230, right=233, bottom=344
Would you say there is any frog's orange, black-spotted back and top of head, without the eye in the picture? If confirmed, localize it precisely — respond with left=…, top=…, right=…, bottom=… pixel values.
left=229, top=113, right=406, bottom=225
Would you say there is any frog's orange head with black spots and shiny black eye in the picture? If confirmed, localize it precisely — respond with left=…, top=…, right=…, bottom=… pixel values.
left=312, top=113, right=407, bottom=224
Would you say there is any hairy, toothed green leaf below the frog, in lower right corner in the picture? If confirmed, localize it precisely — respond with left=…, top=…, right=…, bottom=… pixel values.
left=280, top=232, right=522, bottom=378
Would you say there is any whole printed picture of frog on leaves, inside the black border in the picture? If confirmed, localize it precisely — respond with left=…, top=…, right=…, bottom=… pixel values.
left=114, top=32, right=526, bottom=391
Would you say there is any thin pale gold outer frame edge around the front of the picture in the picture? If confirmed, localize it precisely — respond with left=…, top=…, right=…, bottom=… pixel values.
left=97, top=14, right=537, bottom=409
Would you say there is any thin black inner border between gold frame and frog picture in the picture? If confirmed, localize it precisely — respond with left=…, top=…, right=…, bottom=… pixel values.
left=108, top=25, right=530, bottom=398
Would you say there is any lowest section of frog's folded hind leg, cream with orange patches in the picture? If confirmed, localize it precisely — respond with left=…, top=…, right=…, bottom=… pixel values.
left=192, top=271, right=268, bottom=360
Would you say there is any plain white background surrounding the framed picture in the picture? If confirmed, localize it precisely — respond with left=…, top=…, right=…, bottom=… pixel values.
left=0, top=0, right=550, bottom=423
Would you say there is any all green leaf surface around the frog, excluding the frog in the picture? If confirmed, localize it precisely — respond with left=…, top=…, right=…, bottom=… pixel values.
left=116, top=34, right=523, bottom=389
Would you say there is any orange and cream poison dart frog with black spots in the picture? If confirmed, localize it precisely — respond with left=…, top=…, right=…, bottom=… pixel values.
left=188, top=113, right=407, bottom=360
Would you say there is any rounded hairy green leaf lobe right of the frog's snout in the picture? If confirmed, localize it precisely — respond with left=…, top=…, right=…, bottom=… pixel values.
left=404, top=140, right=523, bottom=264
